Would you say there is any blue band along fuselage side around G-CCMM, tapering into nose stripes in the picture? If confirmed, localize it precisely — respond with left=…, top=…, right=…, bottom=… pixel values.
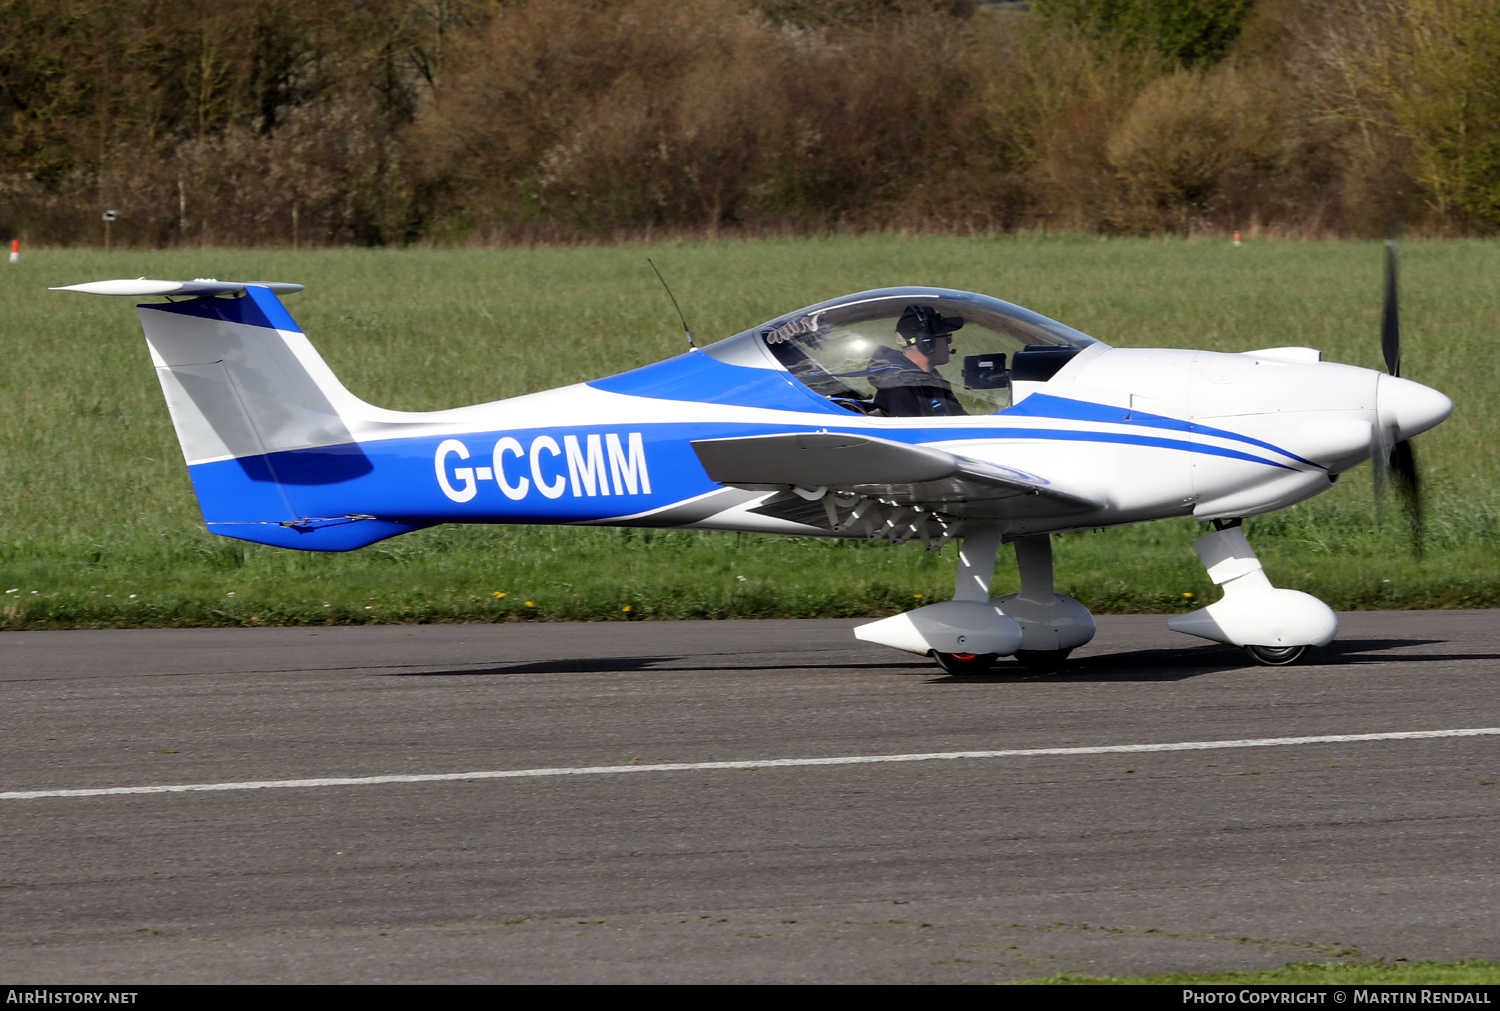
left=189, top=423, right=1292, bottom=551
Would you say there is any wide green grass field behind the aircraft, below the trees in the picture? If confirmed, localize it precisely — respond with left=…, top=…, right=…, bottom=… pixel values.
left=0, top=237, right=1500, bottom=629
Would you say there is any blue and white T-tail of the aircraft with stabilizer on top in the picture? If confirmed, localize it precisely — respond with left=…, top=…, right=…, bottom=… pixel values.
left=54, top=279, right=417, bottom=551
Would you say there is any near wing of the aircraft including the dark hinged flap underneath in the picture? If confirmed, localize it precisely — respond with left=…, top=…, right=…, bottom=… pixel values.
left=693, top=432, right=1106, bottom=536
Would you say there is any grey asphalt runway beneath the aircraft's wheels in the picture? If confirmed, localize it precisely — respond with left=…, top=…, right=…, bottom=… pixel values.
left=0, top=611, right=1500, bottom=984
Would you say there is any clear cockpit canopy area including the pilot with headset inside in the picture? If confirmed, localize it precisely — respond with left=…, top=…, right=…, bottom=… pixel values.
left=708, top=288, right=1098, bottom=417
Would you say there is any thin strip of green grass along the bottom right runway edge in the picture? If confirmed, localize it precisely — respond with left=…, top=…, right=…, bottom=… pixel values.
left=1026, top=959, right=1500, bottom=987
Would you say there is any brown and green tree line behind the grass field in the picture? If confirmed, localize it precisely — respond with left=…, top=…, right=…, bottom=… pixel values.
left=0, top=0, right=1500, bottom=246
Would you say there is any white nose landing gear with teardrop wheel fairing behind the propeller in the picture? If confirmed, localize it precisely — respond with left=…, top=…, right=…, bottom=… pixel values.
left=1167, top=519, right=1338, bottom=668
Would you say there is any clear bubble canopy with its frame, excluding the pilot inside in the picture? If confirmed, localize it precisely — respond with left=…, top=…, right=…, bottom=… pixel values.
left=705, top=288, right=1100, bottom=416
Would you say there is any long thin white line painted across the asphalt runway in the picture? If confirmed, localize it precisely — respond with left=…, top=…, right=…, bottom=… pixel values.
left=0, top=726, right=1500, bottom=801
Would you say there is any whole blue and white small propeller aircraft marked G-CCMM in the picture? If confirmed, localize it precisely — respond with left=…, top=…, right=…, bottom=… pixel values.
left=52, top=253, right=1452, bottom=672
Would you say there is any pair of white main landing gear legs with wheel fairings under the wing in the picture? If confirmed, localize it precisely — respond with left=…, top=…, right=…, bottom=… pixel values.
left=854, top=527, right=1094, bottom=674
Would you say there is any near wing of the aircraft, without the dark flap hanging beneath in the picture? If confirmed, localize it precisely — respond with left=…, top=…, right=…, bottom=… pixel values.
left=693, top=432, right=1101, bottom=507
